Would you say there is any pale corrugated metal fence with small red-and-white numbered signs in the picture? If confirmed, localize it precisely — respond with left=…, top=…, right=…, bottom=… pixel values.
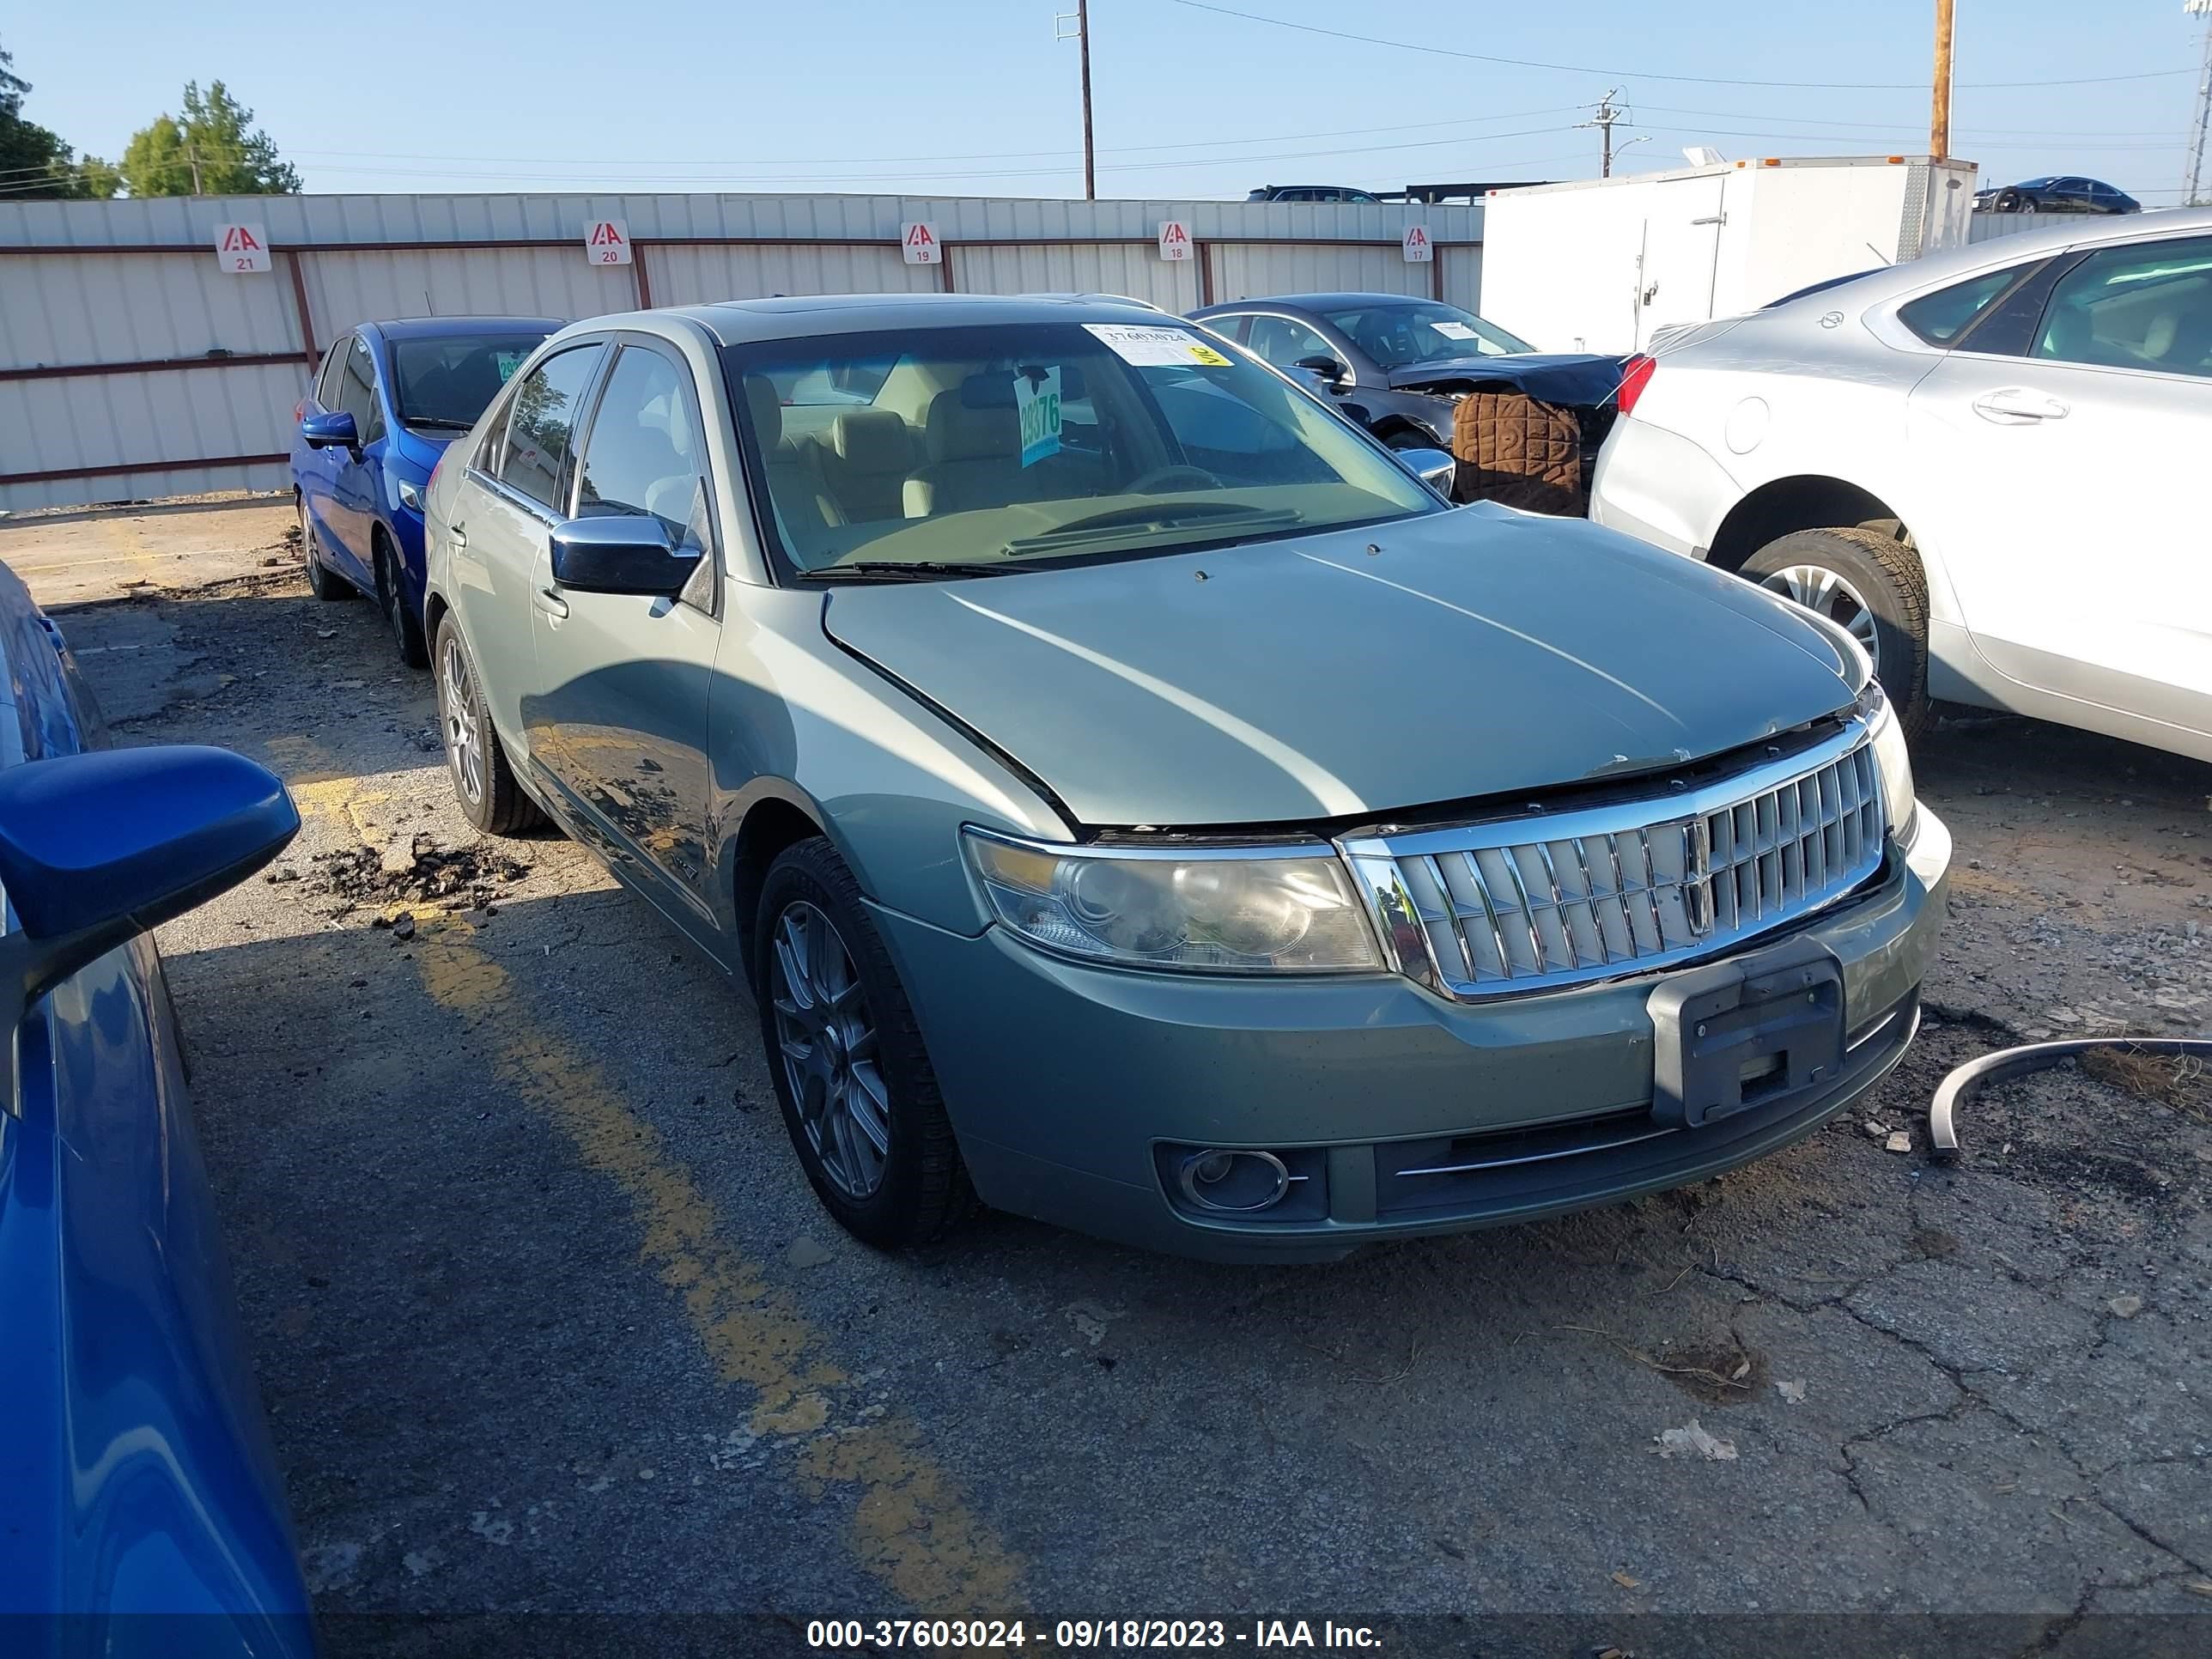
left=0, top=195, right=1482, bottom=508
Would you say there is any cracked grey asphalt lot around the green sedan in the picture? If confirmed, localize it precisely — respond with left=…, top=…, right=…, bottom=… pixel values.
left=30, top=506, right=2212, bottom=1655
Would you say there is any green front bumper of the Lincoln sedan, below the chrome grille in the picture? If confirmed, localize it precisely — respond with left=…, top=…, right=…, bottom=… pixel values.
left=876, top=807, right=1951, bottom=1261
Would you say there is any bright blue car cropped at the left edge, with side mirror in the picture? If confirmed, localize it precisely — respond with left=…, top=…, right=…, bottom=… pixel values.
left=0, top=566, right=314, bottom=1659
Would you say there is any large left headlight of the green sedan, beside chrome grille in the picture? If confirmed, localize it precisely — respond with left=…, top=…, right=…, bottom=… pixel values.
left=964, top=830, right=1382, bottom=973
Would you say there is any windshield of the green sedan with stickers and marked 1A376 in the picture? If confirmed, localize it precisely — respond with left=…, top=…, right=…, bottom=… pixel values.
left=726, top=323, right=1443, bottom=580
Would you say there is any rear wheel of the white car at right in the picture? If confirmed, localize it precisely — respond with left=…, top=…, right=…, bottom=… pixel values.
left=1739, top=526, right=1929, bottom=737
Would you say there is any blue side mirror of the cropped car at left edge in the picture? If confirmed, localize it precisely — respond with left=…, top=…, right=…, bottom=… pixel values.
left=0, top=745, right=299, bottom=1030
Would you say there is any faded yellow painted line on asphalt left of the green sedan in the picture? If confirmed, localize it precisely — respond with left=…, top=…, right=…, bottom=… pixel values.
left=414, top=918, right=1022, bottom=1617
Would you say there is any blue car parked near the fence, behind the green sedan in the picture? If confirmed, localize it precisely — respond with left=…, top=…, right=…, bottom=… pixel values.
left=292, top=316, right=562, bottom=668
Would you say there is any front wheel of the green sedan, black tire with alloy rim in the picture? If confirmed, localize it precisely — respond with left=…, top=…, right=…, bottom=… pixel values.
left=754, top=836, right=975, bottom=1249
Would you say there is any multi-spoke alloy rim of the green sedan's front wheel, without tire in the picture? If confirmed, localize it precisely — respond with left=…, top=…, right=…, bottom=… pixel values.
left=768, top=900, right=891, bottom=1199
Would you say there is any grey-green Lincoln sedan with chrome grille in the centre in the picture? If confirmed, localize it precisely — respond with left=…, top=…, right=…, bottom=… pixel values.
left=427, top=295, right=1951, bottom=1259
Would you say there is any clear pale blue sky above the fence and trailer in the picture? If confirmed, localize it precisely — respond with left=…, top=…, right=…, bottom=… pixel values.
left=0, top=0, right=2201, bottom=206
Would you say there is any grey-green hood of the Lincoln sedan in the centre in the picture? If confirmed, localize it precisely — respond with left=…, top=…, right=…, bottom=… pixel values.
left=825, top=504, right=1863, bottom=827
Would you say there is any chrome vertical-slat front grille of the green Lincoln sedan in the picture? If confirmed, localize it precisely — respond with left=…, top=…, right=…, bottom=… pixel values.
left=1343, top=721, right=1885, bottom=998
